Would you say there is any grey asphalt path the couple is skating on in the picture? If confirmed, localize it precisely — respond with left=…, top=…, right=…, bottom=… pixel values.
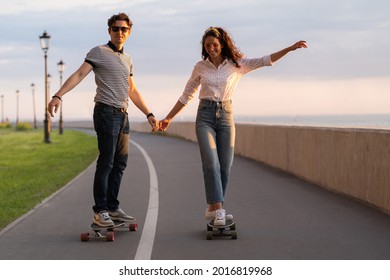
left=0, top=133, right=390, bottom=260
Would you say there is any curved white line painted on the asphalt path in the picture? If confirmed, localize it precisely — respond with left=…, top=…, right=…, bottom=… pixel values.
left=130, top=140, right=158, bottom=260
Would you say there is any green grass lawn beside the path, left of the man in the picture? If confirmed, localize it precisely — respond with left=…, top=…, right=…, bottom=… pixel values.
left=0, top=128, right=98, bottom=229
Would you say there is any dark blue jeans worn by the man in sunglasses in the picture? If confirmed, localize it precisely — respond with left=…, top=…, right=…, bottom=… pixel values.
left=93, top=103, right=130, bottom=213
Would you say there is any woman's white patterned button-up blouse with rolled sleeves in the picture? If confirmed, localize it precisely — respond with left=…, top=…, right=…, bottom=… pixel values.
left=179, top=55, right=272, bottom=105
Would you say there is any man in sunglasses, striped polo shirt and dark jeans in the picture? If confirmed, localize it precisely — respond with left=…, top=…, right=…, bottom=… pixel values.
left=48, top=13, right=158, bottom=227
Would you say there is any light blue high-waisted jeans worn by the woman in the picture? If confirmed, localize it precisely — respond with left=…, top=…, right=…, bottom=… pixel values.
left=196, top=99, right=235, bottom=204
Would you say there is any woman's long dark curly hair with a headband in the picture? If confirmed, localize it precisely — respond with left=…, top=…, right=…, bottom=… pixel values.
left=202, top=27, right=244, bottom=68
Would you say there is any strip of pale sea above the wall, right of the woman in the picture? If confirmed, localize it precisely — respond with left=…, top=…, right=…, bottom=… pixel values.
left=235, top=114, right=390, bottom=129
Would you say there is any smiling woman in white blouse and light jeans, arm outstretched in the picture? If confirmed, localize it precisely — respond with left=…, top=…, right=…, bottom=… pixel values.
left=160, top=27, right=307, bottom=225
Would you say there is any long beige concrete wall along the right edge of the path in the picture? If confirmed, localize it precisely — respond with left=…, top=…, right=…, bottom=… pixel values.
left=132, top=122, right=390, bottom=214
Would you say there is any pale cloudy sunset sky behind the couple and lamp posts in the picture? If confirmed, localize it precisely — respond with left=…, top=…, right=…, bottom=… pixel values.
left=0, top=0, right=390, bottom=122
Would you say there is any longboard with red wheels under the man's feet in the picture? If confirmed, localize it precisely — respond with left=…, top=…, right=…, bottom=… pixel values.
left=80, top=221, right=138, bottom=241
